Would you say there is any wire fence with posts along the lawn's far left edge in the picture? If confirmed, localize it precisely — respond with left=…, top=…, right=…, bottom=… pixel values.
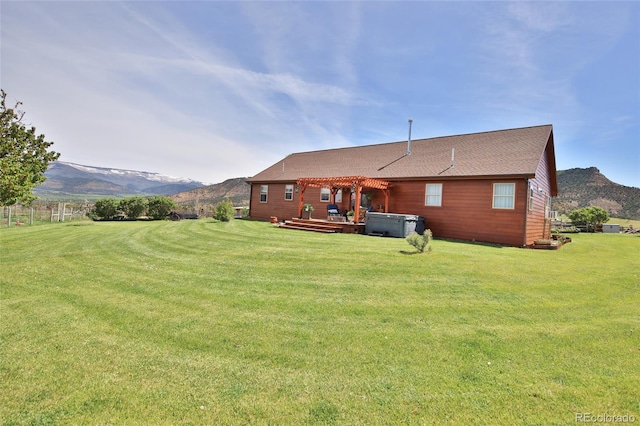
left=0, top=203, right=90, bottom=226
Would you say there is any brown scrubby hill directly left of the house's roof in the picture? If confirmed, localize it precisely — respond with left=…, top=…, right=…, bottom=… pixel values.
left=170, top=178, right=251, bottom=210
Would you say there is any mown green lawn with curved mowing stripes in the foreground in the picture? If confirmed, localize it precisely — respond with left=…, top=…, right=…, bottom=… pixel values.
left=0, top=220, right=640, bottom=425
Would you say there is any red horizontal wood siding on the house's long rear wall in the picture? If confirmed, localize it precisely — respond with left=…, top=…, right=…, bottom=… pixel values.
left=251, top=178, right=532, bottom=246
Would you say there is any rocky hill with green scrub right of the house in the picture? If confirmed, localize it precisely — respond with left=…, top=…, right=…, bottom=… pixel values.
left=552, top=167, right=640, bottom=220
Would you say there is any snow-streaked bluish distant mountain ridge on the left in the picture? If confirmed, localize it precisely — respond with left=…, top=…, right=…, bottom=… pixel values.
left=33, top=161, right=204, bottom=199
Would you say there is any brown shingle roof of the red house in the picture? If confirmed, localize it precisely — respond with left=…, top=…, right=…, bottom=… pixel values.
left=248, top=125, right=553, bottom=182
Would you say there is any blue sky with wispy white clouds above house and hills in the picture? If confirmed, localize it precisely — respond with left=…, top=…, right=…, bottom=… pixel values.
left=0, top=1, right=640, bottom=187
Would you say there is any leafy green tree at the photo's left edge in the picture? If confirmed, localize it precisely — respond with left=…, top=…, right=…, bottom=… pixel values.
left=0, top=89, right=60, bottom=206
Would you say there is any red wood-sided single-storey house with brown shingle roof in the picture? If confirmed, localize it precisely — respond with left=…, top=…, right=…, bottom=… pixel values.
left=247, top=125, right=558, bottom=247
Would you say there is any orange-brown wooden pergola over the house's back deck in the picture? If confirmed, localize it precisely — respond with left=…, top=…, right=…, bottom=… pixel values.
left=296, top=176, right=390, bottom=218
